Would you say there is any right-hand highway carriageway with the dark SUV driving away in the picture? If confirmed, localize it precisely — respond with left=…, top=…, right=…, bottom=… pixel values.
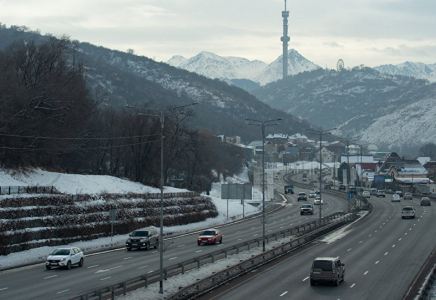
left=201, top=196, right=436, bottom=300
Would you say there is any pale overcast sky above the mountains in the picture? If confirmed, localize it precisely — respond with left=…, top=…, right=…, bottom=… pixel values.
left=0, top=0, right=436, bottom=68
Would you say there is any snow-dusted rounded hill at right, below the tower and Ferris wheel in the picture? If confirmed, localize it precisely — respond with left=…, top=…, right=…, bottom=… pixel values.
left=253, top=67, right=436, bottom=147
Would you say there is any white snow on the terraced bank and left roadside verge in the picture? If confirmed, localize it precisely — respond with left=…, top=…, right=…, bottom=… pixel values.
left=0, top=170, right=259, bottom=270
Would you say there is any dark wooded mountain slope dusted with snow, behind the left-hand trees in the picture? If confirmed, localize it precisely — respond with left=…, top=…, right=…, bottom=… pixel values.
left=0, top=25, right=320, bottom=143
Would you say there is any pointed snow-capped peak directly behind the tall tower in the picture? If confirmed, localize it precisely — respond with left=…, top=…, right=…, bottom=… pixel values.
left=254, top=49, right=320, bottom=85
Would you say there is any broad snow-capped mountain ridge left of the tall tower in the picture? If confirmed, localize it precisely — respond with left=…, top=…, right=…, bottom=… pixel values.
left=168, top=51, right=267, bottom=80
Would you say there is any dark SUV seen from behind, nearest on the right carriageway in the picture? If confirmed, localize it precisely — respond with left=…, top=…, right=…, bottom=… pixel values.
left=310, top=256, right=345, bottom=286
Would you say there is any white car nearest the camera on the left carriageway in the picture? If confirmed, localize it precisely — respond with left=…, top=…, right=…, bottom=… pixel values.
left=45, top=247, right=84, bottom=270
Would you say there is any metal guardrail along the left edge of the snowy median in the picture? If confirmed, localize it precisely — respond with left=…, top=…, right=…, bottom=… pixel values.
left=71, top=212, right=350, bottom=300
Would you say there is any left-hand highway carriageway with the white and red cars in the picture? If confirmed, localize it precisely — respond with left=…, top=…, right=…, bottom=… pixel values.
left=0, top=183, right=347, bottom=300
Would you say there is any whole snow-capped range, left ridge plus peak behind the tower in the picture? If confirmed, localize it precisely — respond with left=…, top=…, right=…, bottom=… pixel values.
left=168, top=49, right=319, bottom=85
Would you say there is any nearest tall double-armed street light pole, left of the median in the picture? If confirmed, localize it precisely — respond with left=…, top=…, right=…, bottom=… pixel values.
left=126, top=102, right=197, bottom=294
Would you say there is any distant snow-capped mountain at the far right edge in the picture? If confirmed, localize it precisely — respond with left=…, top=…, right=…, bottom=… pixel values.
left=374, top=61, right=436, bottom=82
